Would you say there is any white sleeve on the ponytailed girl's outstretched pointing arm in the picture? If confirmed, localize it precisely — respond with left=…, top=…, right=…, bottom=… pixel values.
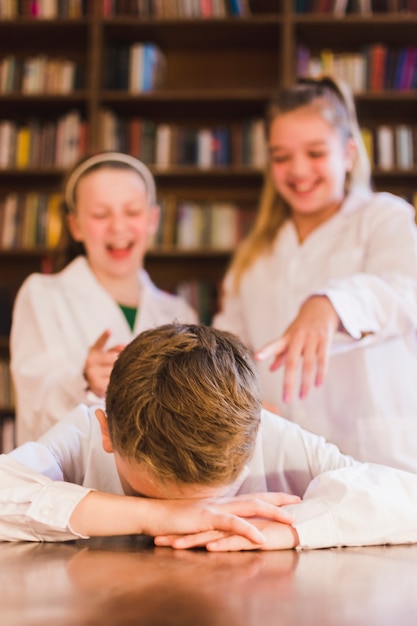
left=318, top=199, right=417, bottom=342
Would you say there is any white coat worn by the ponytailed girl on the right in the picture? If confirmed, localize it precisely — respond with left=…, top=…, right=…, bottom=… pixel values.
left=213, top=193, right=417, bottom=472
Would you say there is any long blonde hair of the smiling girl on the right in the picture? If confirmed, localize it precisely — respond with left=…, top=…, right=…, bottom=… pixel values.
left=229, top=76, right=371, bottom=291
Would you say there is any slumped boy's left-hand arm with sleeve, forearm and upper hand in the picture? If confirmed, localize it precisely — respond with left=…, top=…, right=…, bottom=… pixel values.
left=0, top=455, right=297, bottom=545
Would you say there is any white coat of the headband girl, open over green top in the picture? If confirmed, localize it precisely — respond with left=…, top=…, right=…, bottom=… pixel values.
left=10, top=256, right=197, bottom=444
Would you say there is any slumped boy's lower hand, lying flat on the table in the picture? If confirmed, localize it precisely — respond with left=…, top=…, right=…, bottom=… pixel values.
left=154, top=519, right=300, bottom=552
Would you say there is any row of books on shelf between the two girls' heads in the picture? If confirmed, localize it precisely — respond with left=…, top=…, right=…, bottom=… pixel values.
left=100, top=110, right=267, bottom=168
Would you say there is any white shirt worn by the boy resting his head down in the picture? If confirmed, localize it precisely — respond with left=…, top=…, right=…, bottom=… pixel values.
left=0, top=405, right=417, bottom=548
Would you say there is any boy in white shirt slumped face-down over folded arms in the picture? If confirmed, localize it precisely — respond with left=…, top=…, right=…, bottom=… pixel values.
left=0, top=324, right=417, bottom=550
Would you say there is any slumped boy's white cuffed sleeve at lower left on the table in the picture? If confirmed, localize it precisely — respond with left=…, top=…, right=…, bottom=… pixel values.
left=0, top=455, right=91, bottom=541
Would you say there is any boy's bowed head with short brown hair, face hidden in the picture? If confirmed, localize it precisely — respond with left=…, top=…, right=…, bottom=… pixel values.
left=96, top=323, right=261, bottom=495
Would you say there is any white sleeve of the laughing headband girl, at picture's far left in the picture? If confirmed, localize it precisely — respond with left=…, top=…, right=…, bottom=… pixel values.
left=10, top=275, right=87, bottom=443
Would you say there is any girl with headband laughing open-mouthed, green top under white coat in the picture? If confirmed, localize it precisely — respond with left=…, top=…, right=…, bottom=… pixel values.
left=10, top=152, right=197, bottom=444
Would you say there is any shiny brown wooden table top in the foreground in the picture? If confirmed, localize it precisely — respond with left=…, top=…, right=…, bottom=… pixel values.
left=0, top=537, right=417, bottom=626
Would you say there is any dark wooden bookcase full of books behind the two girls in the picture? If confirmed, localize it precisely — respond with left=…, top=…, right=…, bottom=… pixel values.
left=0, top=0, right=417, bottom=451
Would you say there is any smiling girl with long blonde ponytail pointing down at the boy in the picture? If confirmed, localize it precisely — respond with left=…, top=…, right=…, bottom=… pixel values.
left=214, top=77, right=417, bottom=472
